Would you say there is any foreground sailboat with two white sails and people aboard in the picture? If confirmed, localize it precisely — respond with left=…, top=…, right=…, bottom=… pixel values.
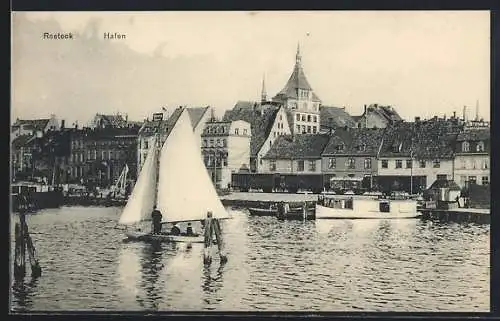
left=118, top=109, right=230, bottom=243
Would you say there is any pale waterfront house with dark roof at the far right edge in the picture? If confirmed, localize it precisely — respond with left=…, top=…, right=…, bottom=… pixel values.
left=453, top=128, right=491, bottom=188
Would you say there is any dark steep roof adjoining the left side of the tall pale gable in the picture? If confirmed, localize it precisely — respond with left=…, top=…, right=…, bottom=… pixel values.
left=223, top=102, right=282, bottom=156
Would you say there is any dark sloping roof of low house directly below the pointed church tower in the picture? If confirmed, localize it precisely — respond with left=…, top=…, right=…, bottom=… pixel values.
left=263, top=134, right=330, bottom=159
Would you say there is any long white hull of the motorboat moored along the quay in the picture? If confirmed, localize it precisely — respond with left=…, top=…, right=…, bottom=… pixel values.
left=316, top=205, right=420, bottom=219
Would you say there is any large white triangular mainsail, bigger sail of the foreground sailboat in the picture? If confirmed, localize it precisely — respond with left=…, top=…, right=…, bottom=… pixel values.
left=157, top=109, right=229, bottom=222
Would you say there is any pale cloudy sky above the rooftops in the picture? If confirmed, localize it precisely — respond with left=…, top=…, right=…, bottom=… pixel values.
left=11, top=11, right=490, bottom=124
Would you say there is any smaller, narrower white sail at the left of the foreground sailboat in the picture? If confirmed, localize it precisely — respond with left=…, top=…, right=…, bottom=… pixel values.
left=118, top=138, right=158, bottom=224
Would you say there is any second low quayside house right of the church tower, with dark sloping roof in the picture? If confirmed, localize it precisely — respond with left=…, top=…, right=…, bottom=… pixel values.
left=321, top=128, right=384, bottom=188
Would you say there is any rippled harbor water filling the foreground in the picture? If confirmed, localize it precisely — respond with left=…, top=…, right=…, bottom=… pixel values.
left=10, top=207, right=490, bottom=312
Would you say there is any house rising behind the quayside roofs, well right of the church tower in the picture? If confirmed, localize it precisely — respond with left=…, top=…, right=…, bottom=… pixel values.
left=355, top=104, right=402, bottom=128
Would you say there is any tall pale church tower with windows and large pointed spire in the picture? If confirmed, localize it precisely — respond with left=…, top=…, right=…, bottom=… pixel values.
left=272, top=44, right=321, bottom=134
